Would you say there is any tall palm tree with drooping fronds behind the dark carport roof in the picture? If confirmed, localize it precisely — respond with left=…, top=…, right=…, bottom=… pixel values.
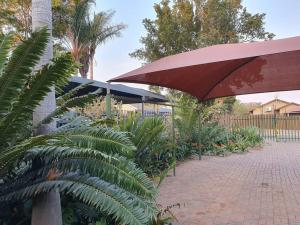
left=64, top=0, right=125, bottom=79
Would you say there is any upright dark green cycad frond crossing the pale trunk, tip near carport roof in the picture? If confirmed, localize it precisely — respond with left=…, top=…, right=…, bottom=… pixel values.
left=0, top=54, right=74, bottom=148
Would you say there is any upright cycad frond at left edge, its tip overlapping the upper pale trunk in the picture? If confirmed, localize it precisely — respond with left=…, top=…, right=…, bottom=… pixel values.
left=0, top=28, right=49, bottom=115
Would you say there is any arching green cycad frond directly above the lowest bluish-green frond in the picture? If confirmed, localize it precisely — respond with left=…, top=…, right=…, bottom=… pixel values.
left=27, top=146, right=156, bottom=199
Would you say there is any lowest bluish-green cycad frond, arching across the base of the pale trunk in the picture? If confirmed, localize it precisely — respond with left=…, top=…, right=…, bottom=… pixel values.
left=0, top=173, right=156, bottom=225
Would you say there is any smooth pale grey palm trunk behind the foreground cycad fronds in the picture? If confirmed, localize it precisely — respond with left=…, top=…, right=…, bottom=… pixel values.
left=31, top=0, right=62, bottom=225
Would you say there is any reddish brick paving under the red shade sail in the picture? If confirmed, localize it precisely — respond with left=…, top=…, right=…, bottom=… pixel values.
left=158, top=143, right=300, bottom=225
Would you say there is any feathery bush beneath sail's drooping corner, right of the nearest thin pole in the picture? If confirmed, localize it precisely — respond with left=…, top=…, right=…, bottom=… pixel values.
left=175, top=96, right=228, bottom=160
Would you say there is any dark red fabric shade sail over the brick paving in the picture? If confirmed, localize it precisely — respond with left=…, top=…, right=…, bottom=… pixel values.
left=110, top=37, right=300, bottom=100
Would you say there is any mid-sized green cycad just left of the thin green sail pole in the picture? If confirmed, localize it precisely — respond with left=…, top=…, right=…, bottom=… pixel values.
left=120, top=116, right=174, bottom=176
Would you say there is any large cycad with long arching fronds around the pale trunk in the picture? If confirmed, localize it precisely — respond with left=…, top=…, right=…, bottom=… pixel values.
left=0, top=29, right=156, bottom=225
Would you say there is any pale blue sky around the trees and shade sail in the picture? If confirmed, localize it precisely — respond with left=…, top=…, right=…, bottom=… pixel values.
left=94, top=0, right=300, bottom=103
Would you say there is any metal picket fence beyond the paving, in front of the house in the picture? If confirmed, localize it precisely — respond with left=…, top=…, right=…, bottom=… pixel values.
left=219, top=114, right=300, bottom=141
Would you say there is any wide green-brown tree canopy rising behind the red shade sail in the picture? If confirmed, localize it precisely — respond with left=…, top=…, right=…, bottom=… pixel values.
left=130, top=0, right=274, bottom=63
